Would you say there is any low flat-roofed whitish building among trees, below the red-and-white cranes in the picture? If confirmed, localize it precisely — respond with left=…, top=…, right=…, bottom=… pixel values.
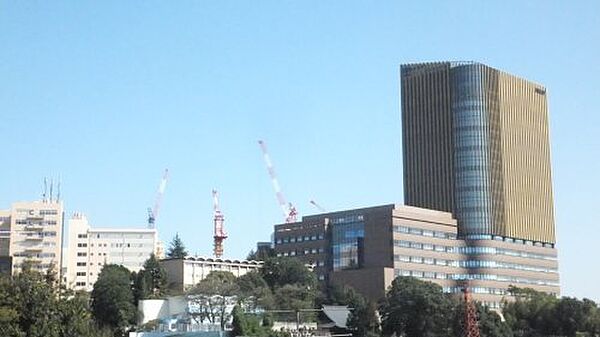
left=160, top=257, right=263, bottom=291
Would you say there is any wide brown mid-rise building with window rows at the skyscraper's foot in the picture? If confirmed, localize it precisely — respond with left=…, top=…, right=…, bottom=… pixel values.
left=274, top=204, right=560, bottom=308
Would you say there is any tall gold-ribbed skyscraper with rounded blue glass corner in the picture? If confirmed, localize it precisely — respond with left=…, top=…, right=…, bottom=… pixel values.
left=401, top=62, right=555, bottom=246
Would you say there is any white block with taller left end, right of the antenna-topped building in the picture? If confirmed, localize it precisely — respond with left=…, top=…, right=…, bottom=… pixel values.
left=66, top=213, right=162, bottom=291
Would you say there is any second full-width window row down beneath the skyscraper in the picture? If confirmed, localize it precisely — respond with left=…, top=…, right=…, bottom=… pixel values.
left=394, top=255, right=558, bottom=273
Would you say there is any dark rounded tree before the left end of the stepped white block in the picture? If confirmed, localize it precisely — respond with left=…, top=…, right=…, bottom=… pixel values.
left=92, top=264, right=136, bottom=334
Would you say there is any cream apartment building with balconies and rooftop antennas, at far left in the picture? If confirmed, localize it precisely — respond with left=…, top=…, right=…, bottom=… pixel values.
left=0, top=199, right=64, bottom=277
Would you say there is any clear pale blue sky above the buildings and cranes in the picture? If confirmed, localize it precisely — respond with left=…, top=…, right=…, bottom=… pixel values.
left=0, top=0, right=600, bottom=300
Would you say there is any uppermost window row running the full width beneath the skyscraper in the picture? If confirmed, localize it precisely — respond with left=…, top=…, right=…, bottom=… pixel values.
left=394, top=236, right=556, bottom=260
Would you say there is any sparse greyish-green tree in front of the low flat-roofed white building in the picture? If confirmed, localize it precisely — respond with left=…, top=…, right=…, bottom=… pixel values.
left=187, top=271, right=239, bottom=330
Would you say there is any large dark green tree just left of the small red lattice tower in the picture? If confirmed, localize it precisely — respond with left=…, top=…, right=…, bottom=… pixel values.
left=380, top=276, right=454, bottom=337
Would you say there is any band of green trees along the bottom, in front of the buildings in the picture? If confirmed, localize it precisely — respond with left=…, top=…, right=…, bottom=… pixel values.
left=0, top=236, right=600, bottom=337
